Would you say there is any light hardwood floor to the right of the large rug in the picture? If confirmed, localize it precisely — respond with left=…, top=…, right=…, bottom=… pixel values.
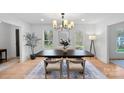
left=88, top=58, right=124, bottom=79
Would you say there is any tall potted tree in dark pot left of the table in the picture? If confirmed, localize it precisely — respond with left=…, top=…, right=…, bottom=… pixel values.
left=24, top=33, right=41, bottom=59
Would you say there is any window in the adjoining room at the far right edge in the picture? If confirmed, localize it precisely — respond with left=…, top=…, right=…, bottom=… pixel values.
left=117, top=31, right=124, bottom=52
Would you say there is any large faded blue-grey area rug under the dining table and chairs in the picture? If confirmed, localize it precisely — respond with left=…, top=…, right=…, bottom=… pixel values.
left=25, top=61, right=107, bottom=79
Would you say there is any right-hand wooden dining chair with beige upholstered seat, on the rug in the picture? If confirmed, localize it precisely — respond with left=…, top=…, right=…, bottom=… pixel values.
left=66, top=58, right=85, bottom=78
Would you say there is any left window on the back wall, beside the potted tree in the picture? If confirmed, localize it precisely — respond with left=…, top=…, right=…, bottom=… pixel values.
left=44, top=30, right=53, bottom=48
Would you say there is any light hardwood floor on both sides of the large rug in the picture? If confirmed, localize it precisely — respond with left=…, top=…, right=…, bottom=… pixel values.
left=0, top=57, right=124, bottom=79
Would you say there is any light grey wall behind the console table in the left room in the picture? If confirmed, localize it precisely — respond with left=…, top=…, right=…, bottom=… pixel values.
left=0, top=22, right=20, bottom=59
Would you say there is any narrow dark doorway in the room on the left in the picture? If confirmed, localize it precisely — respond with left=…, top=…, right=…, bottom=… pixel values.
left=15, top=28, right=20, bottom=57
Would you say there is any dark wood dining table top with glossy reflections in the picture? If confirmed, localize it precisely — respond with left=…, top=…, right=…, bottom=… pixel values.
left=37, top=49, right=94, bottom=58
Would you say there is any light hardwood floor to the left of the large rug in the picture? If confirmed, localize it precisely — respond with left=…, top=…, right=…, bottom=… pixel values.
left=0, top=58, right=42, bottom=79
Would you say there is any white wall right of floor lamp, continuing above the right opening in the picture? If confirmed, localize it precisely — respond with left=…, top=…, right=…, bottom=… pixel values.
left=96, top=15, right=124, bottom=63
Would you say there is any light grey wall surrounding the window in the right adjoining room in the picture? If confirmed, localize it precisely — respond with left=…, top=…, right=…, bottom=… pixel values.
left=108, top=22, right=124, bottom=59
